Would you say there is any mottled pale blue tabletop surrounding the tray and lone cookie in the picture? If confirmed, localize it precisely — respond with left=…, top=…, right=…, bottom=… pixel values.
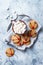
left=0, top=0, right=43, bottom=65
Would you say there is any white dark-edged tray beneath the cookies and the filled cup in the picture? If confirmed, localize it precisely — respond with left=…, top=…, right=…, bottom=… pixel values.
left=5, top=14, right=41, bottom=50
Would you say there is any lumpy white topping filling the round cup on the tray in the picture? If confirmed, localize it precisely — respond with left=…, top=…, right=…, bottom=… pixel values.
left=14, top=20, right=26, bottom=34
